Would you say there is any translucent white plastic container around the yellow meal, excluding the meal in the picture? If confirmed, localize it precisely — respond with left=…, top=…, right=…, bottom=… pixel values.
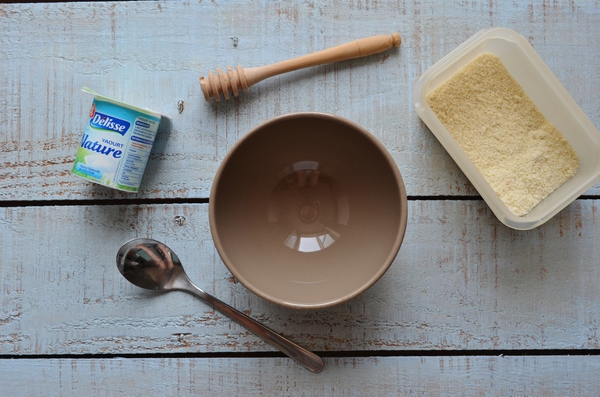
left=413, top=28, right=600, bottom=230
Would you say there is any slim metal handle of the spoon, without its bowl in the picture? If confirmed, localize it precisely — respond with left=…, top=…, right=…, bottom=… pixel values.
left=185, top=282, right=324, bottom=372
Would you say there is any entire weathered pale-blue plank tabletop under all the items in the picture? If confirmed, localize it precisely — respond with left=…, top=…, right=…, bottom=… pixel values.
left=0, top=0, right=600, bottom=396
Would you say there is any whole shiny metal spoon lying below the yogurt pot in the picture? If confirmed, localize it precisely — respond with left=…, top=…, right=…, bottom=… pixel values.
left=117, top=238, right=323, bottom=372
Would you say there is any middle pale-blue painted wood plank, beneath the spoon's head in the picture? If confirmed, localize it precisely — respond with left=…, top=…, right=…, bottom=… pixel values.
left=0, top=200, right=600, bottom=355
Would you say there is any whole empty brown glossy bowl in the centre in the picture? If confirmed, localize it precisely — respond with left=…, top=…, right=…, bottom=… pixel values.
left=209, top=113, right=407, bottom=309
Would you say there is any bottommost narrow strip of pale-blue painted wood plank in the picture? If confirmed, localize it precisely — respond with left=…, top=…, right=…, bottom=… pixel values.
left=0, top=356, right=600, bottom=397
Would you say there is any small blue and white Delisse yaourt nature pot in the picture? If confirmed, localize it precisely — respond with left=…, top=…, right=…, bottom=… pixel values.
left=71, top=87, right=161, bottom=192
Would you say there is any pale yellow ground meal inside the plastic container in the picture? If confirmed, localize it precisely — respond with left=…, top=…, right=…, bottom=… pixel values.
left=427, top=54, right=579, bottom=216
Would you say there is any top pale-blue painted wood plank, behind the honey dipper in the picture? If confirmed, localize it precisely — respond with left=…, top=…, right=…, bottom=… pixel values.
left=0, top=0, right=600, bottom=200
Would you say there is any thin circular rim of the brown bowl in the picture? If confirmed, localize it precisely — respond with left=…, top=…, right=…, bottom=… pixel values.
left=208, top=112, right=408, bottom=309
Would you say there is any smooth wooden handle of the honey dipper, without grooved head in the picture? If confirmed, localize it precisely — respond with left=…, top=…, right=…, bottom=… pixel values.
left=244, top=33, right=401, bottom=87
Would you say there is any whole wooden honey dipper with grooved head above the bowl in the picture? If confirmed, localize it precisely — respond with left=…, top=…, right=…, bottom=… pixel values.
left=200, top=33, right=402, bottom=102
